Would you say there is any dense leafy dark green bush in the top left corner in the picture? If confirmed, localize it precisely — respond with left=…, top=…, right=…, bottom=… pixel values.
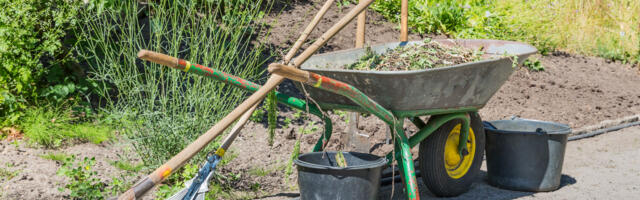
left=0, top=0, right=92, bottom=126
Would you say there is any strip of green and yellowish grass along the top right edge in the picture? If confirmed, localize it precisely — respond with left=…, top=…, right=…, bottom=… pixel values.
left=372, top=0, right=640, bottom=62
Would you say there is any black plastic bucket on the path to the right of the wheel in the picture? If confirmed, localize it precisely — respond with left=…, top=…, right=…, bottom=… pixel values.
left=485, top=119, right=571, bottom=192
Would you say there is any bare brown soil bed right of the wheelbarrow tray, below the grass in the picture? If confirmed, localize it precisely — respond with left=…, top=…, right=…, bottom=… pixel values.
left=480, top=52, right=640, bottom=128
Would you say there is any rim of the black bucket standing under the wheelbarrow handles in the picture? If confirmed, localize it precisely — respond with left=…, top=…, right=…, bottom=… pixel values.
left=293, top=151, right=387, bottom=170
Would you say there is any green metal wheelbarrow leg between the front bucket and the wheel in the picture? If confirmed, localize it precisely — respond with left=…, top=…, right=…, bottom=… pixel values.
left=395, top=120, right=420, bottom=200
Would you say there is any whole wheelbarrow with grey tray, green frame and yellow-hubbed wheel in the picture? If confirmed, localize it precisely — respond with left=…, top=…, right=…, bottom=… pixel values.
left=145, top=39, right=537, bottom=199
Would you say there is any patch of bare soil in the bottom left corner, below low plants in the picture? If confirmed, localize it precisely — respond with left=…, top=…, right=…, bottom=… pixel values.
left=0, top=140, right=155, bottom=199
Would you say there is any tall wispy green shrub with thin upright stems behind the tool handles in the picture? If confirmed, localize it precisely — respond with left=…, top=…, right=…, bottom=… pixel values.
left=78, top=0, right=272, bottom=168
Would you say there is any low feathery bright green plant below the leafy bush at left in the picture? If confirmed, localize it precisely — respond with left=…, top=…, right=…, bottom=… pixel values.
left=20, top=106, right=113, bottom=148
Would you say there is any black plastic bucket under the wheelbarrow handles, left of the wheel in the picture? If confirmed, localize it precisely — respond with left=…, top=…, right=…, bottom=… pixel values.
left=294, top=152, right=387, bottom=200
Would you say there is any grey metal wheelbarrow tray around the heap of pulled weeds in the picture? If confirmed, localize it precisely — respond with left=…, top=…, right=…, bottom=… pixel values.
left=302, top=39, right=537, bottom=116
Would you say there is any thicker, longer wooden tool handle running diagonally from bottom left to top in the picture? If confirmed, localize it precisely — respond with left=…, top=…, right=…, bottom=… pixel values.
left=118, top=0, right=373, bottom=200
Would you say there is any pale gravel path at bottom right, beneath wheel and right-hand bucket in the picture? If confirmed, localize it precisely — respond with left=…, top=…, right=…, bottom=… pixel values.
left=380, top=126, right=640, bottom=199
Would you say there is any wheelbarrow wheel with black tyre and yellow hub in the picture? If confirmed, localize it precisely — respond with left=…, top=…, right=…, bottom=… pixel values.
left=419, top=112, right=485, bottom=197
